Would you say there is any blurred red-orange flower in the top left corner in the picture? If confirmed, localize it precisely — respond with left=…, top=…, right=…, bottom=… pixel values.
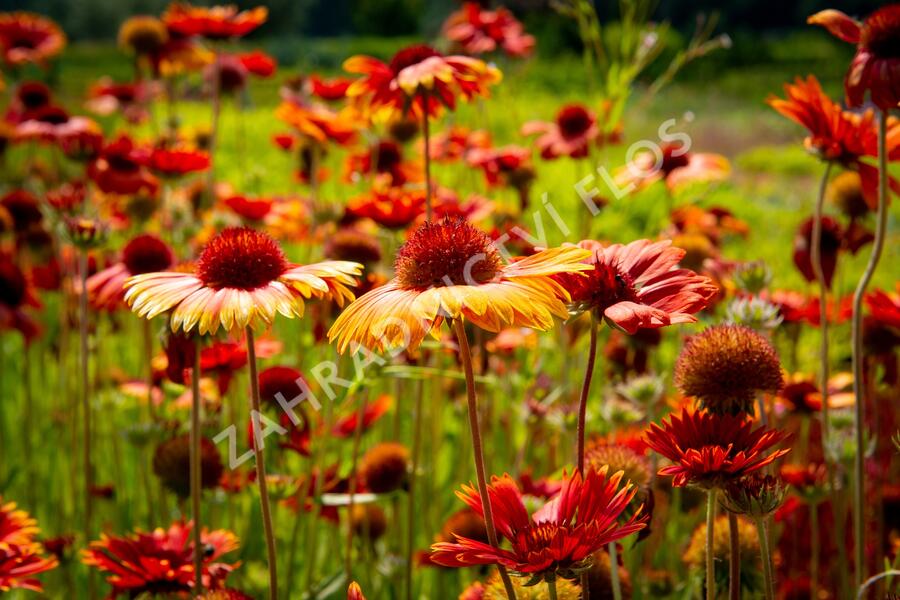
left=0, top=11, right=66, bottom=66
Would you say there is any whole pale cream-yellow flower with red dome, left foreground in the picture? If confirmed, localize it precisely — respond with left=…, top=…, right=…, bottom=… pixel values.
left=125, top=227, right=362, bottom=335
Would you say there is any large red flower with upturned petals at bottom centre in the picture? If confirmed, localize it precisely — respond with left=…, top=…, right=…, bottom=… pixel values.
left=431, top=468, right=646, bottom=582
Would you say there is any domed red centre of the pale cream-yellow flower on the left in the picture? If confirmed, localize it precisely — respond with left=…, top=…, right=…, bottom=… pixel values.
left=197, top=227, right=288, bottom=290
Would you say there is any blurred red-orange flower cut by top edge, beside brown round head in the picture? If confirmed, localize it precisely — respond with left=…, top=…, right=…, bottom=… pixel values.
left=163, top=2, right=269, bottom=40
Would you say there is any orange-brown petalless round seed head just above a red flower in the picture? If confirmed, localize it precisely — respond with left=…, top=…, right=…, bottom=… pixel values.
left=675, top=325, right=784, bottom=415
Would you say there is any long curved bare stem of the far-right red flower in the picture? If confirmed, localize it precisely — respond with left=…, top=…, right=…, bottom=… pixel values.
left=851, top=105, right=888, bottom=588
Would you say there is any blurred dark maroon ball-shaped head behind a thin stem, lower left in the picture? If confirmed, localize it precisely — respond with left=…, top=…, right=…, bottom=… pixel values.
left=153, top=433, right=224, bottom=498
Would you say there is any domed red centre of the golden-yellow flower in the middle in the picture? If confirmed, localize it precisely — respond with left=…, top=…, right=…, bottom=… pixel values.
left=394, top=218, right=503, bottom=290
